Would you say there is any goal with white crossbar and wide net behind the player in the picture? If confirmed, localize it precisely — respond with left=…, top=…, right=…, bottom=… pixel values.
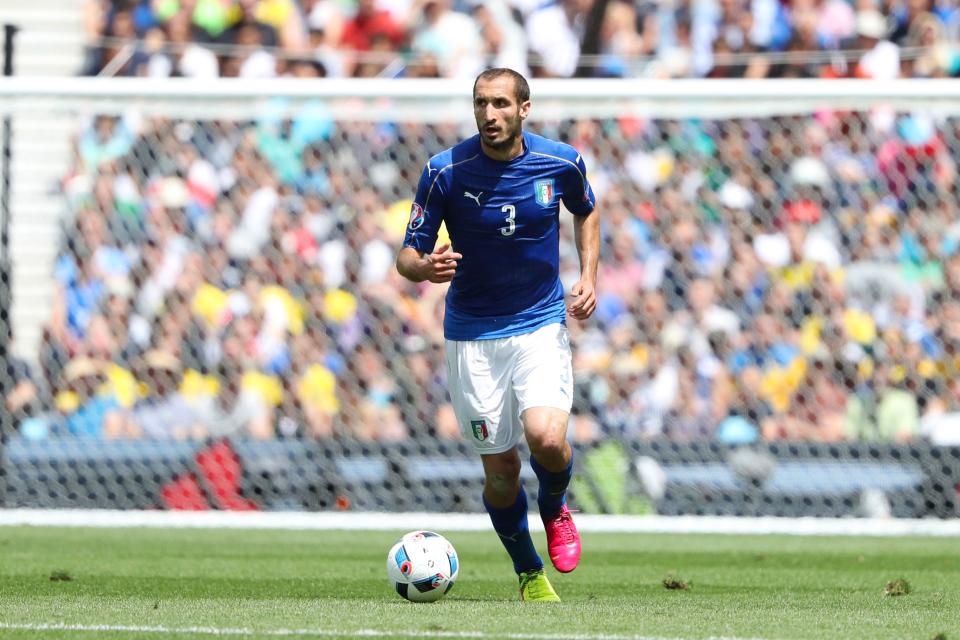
left=0, top=79, right=960, bottom=517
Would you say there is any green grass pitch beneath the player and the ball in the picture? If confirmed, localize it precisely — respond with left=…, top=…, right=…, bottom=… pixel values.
left=0, top=516, right=960, bottom=640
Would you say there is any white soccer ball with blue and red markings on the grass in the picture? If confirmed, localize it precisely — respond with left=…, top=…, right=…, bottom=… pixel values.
left=387, top=531, right=460, bottom=602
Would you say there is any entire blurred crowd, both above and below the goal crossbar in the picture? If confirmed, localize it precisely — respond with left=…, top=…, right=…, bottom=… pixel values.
left=6, top=0, right=960, bottom=443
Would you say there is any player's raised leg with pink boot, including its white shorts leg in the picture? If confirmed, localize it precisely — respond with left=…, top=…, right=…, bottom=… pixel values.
left=514, top=324, right=581, bottom=573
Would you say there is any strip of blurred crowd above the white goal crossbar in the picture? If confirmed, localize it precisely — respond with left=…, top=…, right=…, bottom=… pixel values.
left=84, top=0, right=960, bottom=80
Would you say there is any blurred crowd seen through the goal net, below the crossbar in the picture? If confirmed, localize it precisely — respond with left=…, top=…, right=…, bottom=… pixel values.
left=8, top=94, right=960, bottom=450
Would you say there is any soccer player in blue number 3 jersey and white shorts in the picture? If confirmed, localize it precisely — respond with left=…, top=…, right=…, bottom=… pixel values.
left=397, top=69, right=600, bottom=602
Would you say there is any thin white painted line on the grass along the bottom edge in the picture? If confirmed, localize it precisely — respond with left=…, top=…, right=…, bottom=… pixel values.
left=0, top=622, right=759, bottom=640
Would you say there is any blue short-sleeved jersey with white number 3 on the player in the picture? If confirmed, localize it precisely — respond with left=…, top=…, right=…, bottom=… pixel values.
left=403, top=132, right=595, bottom=340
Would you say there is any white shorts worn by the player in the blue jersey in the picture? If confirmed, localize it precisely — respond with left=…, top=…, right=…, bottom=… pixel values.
left=445, top=323, right=573, bottom=454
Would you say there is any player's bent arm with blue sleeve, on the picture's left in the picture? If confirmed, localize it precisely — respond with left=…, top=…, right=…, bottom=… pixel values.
left=397, top=157, right=463, bottom=282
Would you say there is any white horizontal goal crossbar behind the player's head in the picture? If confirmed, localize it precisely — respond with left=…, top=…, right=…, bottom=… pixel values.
left=0, top=77, right=960, bottom=122
